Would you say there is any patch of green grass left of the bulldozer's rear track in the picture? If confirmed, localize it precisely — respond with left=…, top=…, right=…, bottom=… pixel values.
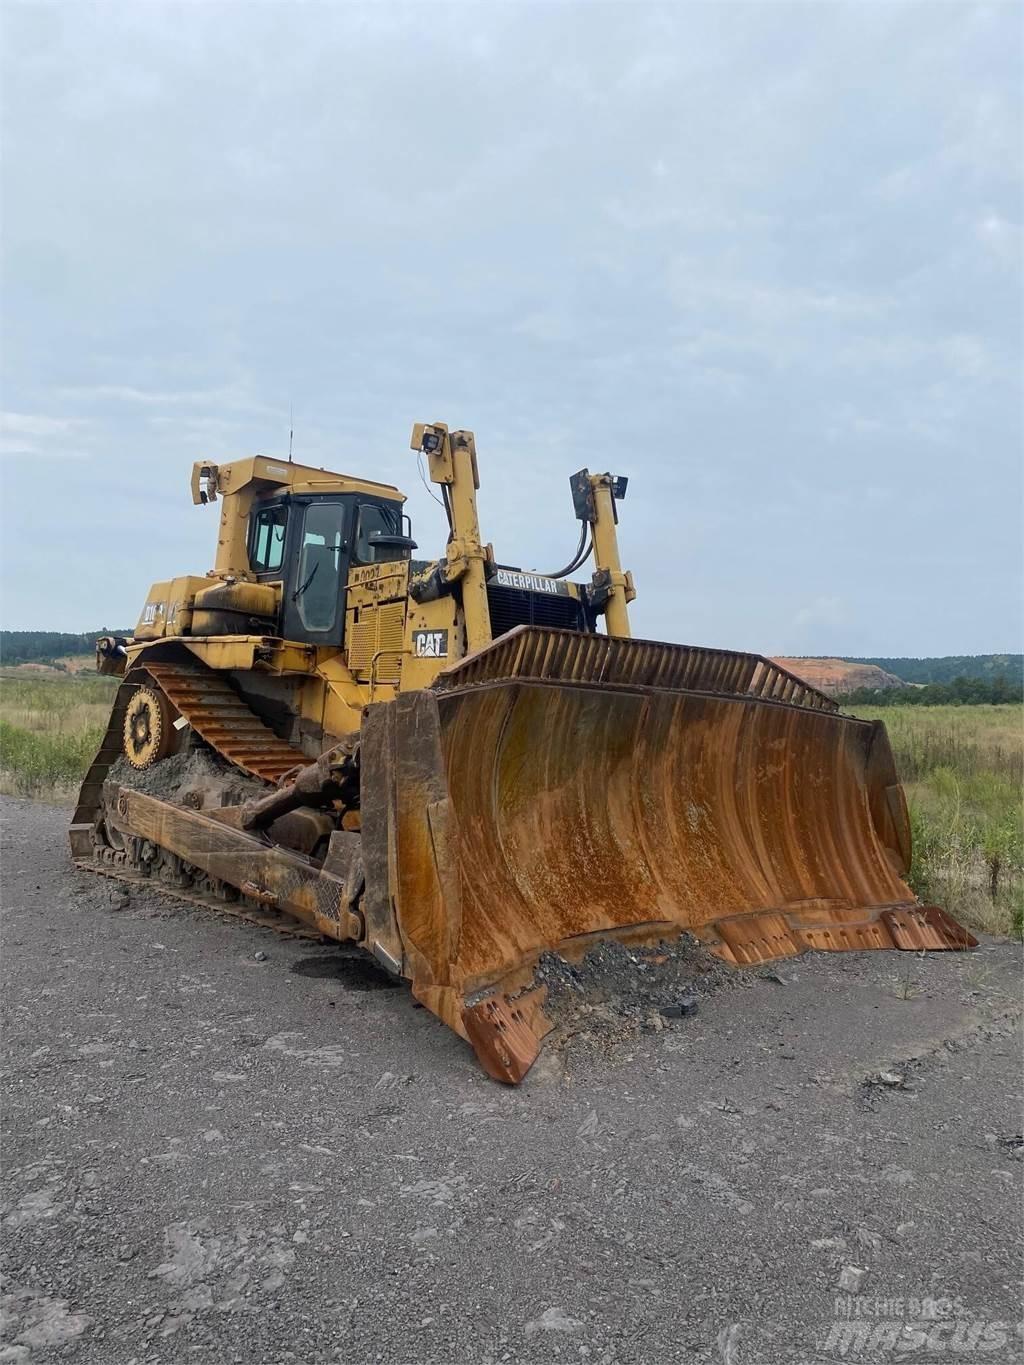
left=0, top=676, right=117, bottom=801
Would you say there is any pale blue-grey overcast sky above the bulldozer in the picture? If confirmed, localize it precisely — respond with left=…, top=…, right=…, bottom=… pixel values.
left=0, top=0, right=1023, bottom=655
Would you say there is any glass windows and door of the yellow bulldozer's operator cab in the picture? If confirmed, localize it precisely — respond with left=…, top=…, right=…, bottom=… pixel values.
left=248, top=493, right=416, bottom=646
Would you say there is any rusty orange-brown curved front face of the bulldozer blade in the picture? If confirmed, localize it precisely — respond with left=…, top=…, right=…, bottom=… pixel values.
left=425, top=683, right=915, bottom=984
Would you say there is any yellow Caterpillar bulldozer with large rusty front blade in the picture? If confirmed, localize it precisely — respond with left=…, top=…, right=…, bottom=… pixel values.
left=70, top=422, right=975, bottom=1084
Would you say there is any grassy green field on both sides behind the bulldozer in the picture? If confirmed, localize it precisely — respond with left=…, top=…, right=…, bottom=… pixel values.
left=0, top=670, right=1024, bottom=934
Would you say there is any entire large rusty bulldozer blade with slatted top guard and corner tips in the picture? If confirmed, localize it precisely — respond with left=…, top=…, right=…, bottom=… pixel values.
left=362, top=628, right=975, bottom=1082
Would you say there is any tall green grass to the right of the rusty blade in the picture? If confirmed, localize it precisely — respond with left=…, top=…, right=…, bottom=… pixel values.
left=853, top=706, right=1024, bottom=936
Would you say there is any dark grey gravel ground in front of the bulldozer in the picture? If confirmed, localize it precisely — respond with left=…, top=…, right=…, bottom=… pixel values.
left=0, top=800, right=1024, bottom=1365
